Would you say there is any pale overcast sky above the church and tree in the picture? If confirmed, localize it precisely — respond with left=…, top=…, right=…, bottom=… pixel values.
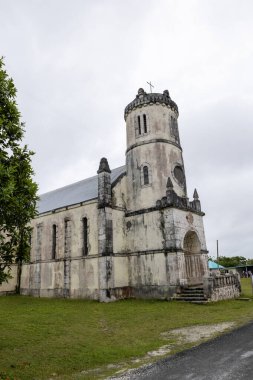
left=0, top=0, right=253, bottom=258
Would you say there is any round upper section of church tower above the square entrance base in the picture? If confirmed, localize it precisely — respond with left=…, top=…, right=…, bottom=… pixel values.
left=125, top=88, right=187, bottom=211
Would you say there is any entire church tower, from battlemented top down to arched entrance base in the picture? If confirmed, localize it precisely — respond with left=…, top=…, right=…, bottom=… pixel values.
left=125, top=88, right=208, bottom=292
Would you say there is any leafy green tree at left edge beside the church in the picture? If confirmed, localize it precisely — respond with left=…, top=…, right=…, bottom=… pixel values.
left=0, top=58, right=37, bottom=292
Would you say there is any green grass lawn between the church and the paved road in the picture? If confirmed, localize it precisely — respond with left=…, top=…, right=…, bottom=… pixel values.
left=0, top=279, right=253, bottom=380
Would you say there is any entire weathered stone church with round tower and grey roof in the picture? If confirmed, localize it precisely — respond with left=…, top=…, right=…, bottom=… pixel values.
left=0, top=89, right=239, bottom=301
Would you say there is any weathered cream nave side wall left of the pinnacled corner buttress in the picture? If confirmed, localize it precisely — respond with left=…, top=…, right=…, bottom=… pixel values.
left=18, top=201, right=99, bottom=299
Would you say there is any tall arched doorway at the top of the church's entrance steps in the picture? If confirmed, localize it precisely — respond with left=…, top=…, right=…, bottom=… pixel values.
left=183, top=231, right=204, bottom=285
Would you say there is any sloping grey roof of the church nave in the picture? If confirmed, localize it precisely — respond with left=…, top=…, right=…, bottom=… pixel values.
left=37, top=165, right=126, bottom=214
